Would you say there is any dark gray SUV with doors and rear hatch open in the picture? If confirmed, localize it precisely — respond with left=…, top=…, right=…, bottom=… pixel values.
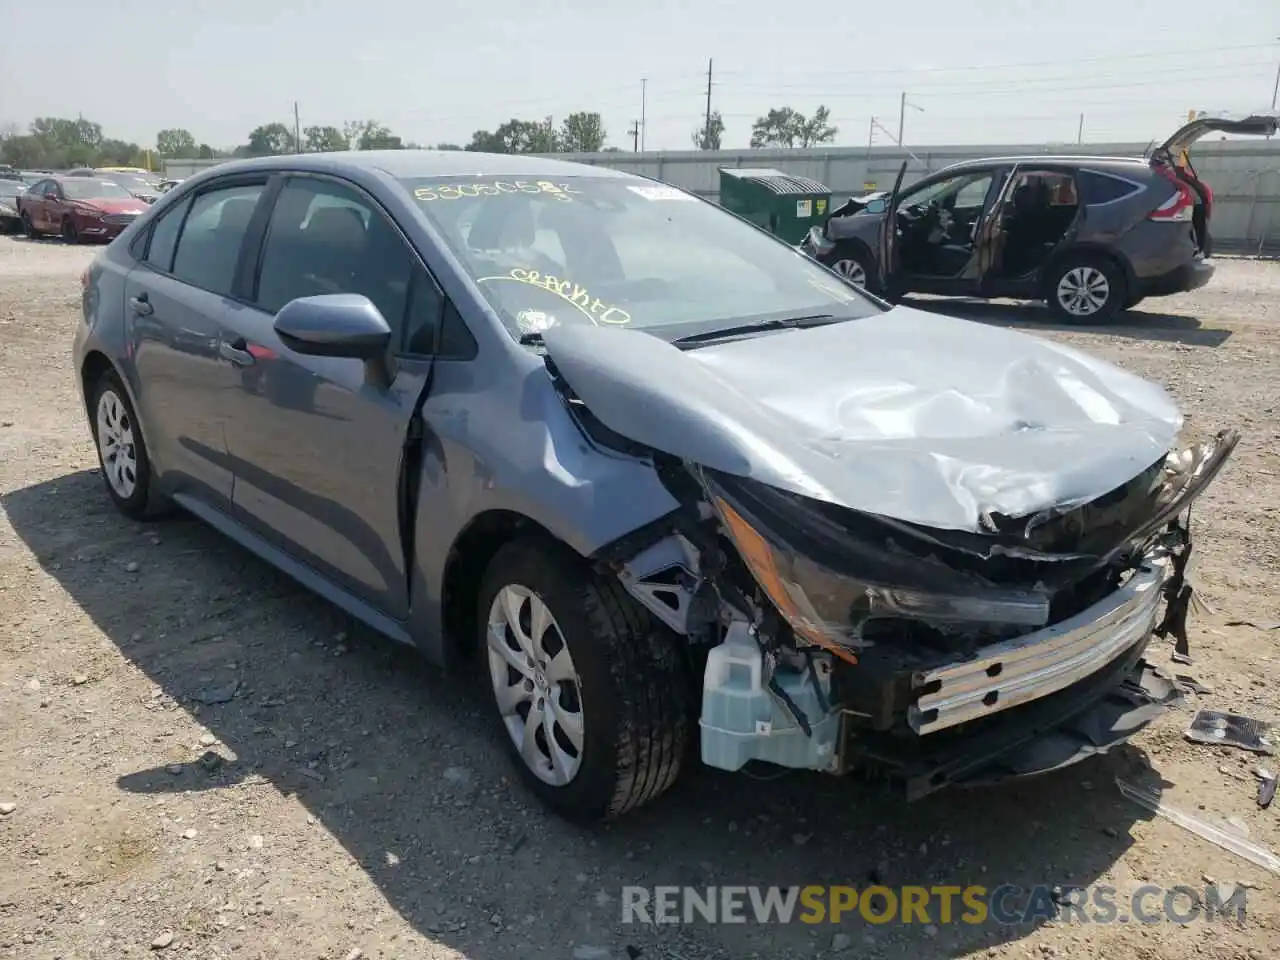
left=800, top=114, right=1277, bottom=323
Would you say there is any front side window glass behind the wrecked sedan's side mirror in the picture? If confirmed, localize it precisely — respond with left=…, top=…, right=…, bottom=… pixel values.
left=257, top=177, right=415, bottom=343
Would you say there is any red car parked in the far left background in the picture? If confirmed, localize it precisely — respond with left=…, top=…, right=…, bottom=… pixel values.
left=18, top=177, right=147, bottom=243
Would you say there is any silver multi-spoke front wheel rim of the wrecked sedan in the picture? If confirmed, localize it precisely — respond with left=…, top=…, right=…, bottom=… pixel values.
left=485, top=584, right=584, bottom=787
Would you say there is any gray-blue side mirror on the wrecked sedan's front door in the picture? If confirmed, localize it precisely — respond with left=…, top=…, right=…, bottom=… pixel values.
left=274, top=293, right=392, bottom=360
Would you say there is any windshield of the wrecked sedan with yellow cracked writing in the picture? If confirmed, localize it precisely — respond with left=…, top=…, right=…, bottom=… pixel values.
left=403, top=177, right=881, bottom=338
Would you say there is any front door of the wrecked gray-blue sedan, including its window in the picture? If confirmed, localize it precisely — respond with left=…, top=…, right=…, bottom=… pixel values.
left=227, top=175, right=444, bottom=621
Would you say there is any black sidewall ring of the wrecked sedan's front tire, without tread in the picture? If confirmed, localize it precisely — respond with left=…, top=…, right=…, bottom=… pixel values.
left=477, top=540, right=645, bottom=822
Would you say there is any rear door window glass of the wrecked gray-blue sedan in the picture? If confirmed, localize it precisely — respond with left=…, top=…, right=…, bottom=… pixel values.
left=173, top=183, right=266, bottom=297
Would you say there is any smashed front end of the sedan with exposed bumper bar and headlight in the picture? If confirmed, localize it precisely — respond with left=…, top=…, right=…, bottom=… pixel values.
left=606, top=431, right=1239, bottom=796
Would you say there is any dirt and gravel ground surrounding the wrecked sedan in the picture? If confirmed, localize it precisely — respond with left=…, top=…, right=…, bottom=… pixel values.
left=0, top=238, right=1280, bottom=960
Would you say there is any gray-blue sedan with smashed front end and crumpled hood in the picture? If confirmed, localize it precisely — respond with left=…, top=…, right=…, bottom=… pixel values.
left=74, top=151, right=1238, bottom=819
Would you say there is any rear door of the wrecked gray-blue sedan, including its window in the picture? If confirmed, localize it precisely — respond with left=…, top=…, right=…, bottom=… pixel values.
left=124, top=175, right=266, bottom=512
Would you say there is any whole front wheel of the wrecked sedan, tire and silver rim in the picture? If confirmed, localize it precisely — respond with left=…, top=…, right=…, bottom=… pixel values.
left=479, top=538, right=690, bottom=822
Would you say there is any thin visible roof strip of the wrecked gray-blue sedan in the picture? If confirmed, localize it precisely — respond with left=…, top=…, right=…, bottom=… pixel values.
left=188, top=150, right=634, bottom=180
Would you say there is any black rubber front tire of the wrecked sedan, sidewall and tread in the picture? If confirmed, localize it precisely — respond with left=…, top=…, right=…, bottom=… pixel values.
left=477, top=538, right=692, bottom=823
